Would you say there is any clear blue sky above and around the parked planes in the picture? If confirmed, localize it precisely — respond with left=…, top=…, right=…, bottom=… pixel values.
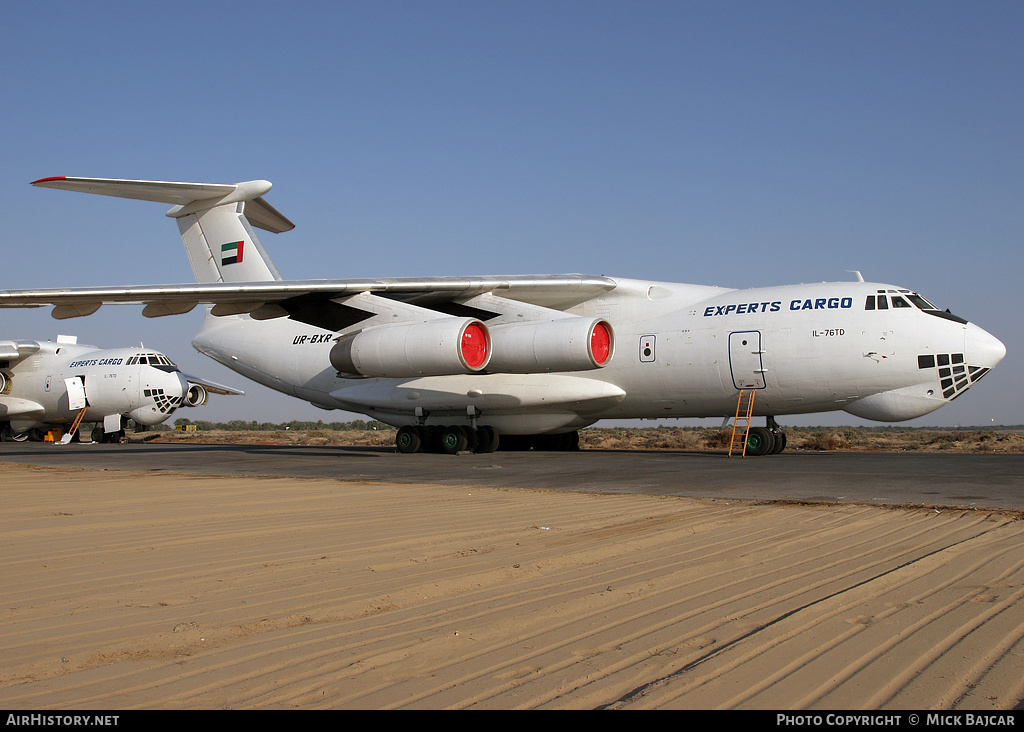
left=0, top=5, right=1024, bottom=425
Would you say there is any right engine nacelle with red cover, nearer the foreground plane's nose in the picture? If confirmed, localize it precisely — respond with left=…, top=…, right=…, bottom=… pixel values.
left=487, top=317, right=614, bottom=374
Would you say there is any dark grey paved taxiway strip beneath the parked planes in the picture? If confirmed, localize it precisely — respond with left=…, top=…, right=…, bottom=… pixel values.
left=0, top=442, right=1024, bottom=511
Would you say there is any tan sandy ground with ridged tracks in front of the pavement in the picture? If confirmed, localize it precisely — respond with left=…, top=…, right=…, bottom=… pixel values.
left=0, top=465, right=1024, bottom=709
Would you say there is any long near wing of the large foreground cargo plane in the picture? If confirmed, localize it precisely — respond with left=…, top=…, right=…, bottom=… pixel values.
left=0, top=274, right=615, bottom=331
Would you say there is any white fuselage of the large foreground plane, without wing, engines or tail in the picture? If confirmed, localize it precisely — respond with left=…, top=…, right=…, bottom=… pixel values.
left=194, top=279, right=1005, bottom=434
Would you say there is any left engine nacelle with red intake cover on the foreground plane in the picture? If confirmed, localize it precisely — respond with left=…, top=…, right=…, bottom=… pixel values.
left=331, top=317, right=490, bottom=378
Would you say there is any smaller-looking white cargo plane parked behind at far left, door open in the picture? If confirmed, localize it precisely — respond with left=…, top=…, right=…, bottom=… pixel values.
left=0, top=336, right=242, bottom=443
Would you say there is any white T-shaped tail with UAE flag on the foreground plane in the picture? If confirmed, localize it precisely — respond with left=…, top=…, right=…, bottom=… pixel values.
left=33, top=177, right=295, bottom=283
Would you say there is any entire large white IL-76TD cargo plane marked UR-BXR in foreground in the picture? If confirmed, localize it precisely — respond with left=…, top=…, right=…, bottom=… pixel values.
left=0, top=177, right=1006, bottom=455
